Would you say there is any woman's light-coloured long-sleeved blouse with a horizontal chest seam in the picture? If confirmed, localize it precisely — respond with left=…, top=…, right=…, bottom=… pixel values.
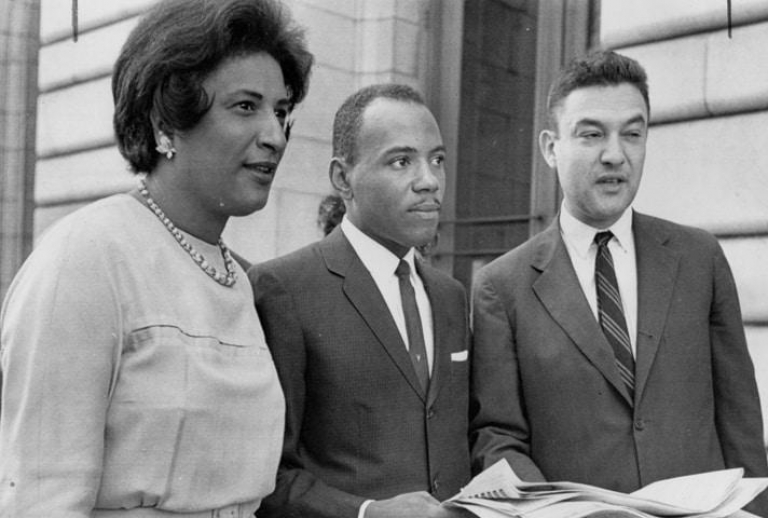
left=0, top=194, right=285, bottom=517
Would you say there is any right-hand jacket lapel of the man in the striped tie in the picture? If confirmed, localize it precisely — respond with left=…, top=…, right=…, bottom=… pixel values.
left=632, top=213, right=679, bottom=401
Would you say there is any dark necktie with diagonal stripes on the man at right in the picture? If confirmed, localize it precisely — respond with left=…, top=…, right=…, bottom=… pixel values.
left=595, top=231, right=635, bottom=399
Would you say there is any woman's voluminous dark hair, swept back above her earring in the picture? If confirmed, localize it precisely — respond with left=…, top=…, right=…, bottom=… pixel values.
left=112, top=0, right=313, bottom=172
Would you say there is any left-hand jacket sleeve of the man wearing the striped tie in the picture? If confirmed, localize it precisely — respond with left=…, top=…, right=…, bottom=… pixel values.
left=470, top=271, right=545, bottom=481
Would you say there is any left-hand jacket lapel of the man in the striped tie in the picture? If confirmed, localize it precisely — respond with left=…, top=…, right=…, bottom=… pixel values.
left=532, top=219, right=632, bottom=405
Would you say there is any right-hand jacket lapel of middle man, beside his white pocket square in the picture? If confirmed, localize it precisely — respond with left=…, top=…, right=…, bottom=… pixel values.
left=417, top=261, right=452, bottom=405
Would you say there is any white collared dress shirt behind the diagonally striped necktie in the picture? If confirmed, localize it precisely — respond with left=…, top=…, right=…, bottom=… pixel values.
left=560, top=206, right=637, bottom=357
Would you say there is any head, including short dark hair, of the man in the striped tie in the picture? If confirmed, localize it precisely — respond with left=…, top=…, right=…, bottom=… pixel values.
left=539, top=52, right=649, bottom=229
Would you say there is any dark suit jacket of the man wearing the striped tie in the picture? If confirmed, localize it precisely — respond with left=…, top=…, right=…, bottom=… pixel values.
left=471, top=213, right=768, bottom=516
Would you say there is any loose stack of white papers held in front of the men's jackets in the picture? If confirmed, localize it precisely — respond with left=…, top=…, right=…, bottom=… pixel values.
left=443, top=460, right=768, bottom=518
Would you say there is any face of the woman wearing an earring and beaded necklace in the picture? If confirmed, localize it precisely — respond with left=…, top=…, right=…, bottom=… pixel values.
left=173, top=52, right=290, bottom=220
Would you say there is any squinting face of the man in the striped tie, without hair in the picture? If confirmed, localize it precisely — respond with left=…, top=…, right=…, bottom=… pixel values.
left=540, top=83, right=648, bottom=229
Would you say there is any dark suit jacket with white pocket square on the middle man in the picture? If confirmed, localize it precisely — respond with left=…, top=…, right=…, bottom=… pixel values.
left=249, top=229, right=470, bottom=518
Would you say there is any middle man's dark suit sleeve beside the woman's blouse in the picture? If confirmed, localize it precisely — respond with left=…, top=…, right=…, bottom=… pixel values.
left=248, top=266, right=365, bottom=518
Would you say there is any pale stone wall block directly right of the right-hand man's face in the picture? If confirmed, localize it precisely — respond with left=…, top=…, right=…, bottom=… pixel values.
left=634, top=112, right=768, bottom=231
